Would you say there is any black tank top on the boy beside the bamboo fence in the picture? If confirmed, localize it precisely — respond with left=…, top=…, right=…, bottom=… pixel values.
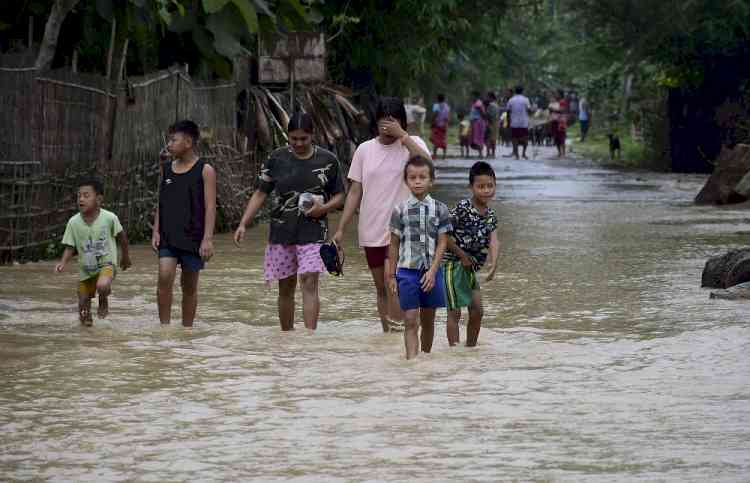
left=159, top=159, right=206, bottom=253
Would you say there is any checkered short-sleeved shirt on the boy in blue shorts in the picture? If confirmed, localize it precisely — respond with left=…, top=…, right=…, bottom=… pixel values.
left=390, top=195, right=452, bottom=270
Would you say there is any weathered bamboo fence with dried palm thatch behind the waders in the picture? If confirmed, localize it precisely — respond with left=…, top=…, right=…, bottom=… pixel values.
left=0, top=56, right=367, bottom=262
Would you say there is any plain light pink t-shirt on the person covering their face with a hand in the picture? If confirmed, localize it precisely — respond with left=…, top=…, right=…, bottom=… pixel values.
left=349, top=136, right=430, bottom=247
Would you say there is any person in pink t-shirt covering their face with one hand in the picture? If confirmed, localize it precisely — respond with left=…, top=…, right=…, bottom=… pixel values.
left=333, top=97, right=430, bottom=332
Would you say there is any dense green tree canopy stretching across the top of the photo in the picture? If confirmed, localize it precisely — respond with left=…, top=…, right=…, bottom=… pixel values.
left=5, top=0, right=750, bottom=170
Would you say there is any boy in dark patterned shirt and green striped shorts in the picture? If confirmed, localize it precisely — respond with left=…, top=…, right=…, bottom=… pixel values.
left=443, top=161, right=498, bottom=347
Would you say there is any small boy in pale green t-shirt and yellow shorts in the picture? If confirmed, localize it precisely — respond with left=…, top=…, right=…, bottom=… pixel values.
left=55, top=179, right=131, bottom=326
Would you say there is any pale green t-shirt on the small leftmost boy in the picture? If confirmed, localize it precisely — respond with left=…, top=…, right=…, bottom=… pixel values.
left=63, top=210, right=122, bottom=280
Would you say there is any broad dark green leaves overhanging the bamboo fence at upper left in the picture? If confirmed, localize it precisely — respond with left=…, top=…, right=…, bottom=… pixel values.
left=0, top=0, right=315, bottom=77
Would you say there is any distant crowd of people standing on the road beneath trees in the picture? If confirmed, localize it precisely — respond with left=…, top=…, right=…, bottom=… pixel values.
left=430, top=86, right=591, bottom=159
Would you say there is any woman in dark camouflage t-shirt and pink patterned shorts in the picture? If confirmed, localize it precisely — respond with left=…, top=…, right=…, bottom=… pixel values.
left=234, top=113, right=344, bottom=330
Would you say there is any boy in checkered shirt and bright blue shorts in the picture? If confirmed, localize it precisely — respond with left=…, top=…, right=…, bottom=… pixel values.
left=386, top=156, right=451, bottom=359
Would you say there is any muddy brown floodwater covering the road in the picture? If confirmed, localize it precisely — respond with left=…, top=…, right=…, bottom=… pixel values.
left=0, top=148, right=750, bottom=482
